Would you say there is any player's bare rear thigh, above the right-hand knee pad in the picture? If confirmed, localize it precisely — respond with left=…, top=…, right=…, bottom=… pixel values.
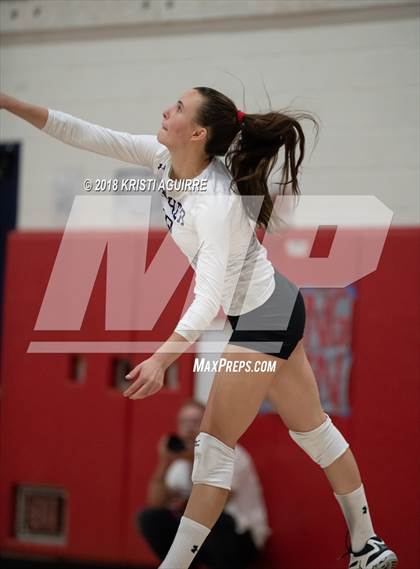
left=268, top=339, right=325, bottom=431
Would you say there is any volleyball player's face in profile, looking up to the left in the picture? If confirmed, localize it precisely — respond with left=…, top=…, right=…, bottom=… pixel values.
left=157, top=89, right=207, bottom=150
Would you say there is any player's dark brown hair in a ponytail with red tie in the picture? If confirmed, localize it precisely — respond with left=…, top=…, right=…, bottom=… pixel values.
left=194, top=87, right=319, bottom=229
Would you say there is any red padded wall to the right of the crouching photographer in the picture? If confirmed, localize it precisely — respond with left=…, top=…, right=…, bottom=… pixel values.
left=241, top=228, right=420, bottom=569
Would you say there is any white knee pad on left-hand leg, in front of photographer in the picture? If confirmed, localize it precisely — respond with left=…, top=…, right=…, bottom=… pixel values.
left=191, top=433, right=235, bottom=490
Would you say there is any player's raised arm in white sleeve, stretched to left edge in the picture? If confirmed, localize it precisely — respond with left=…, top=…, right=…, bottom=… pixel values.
left=0, top=94, right=166, bottom=170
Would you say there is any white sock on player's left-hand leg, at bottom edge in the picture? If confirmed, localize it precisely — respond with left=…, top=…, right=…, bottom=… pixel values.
left=158, top=516, right=210, bottom=569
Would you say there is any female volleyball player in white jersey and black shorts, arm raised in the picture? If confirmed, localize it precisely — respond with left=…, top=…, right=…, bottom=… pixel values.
left=0, top=87, right=397, bottom=569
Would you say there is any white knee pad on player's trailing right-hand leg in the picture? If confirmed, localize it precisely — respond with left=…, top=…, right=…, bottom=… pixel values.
left=289, top=413, right=349, bottom=468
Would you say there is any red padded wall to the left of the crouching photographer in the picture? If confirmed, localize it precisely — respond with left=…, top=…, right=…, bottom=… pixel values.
left=0, top=232, right=193, bottom=563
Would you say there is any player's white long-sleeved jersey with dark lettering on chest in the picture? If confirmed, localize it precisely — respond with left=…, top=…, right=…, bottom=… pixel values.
left=42, top=109, right=275, bottom=343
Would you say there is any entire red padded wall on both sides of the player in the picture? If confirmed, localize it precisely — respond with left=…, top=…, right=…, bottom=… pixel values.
left=0, top=228, right=420, bottom=569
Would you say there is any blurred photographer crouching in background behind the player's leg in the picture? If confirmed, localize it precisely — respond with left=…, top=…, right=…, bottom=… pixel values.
left=137, top=399, right=271, bottom=569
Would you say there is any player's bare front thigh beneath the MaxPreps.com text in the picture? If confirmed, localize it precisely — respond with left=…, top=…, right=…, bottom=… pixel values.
left=200, top=344, right=285, bottom=447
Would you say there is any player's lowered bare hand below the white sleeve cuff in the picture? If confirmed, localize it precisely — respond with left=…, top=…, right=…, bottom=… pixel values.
left=123, top=357, right=165, bottom=399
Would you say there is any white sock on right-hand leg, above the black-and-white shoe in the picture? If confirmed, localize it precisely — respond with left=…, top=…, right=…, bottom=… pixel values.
left=334, top=484, right=375, bottom=553
